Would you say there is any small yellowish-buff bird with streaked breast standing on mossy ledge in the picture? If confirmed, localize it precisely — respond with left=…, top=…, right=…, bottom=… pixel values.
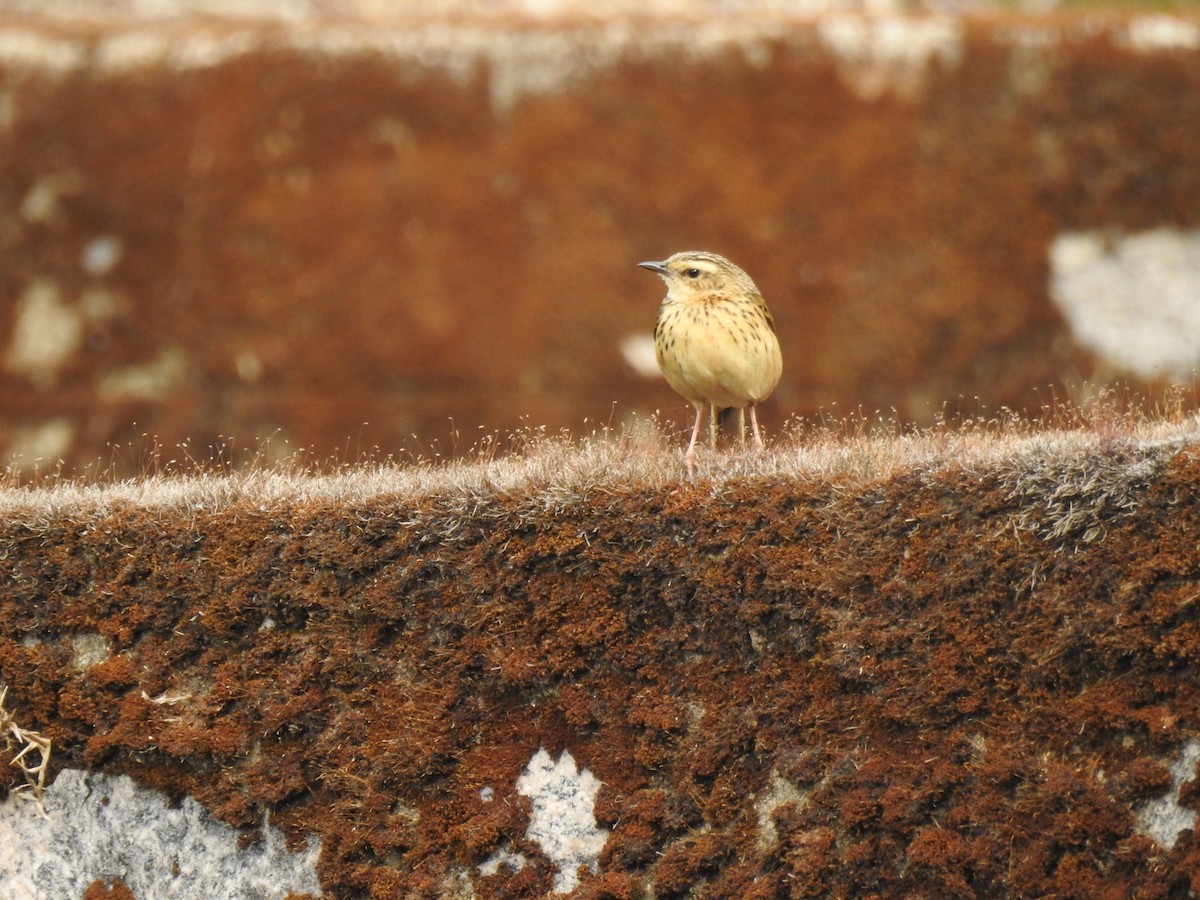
left=638, top=251, right=784, bottom=476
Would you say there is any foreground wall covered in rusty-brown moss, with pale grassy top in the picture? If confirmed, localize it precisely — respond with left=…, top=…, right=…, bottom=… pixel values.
left=0, top=419, right=1200, bottom=898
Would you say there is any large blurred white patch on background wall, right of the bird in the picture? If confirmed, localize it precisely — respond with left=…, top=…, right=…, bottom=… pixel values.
left=1050, top=228, right=1200, bottom=379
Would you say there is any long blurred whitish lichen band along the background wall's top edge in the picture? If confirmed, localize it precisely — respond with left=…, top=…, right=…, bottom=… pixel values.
left=0, top=14, right=962, bottom=115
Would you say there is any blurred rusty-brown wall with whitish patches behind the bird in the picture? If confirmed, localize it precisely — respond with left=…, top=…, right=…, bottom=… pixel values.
left=0, top=0, right=1200, bottom=474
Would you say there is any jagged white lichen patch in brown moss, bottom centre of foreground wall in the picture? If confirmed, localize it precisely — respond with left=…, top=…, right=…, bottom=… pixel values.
left=517, top=749, right=608, bottom=894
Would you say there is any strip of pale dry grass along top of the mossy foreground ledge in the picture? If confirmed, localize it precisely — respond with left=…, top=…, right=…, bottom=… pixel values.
left=0, top=408, right=1200, bottom=528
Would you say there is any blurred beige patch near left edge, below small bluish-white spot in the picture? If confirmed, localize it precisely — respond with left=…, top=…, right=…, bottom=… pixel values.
left=5, top=278, right=83, bottom=388
